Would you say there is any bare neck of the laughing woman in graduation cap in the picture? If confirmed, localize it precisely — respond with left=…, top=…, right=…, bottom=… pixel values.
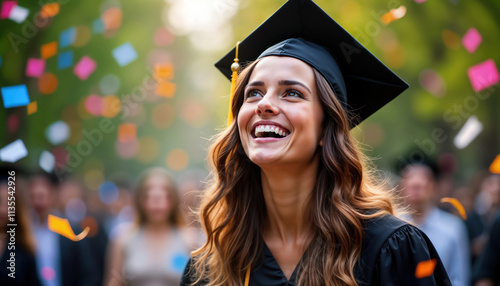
left=261, top=157, right=319, bottom=244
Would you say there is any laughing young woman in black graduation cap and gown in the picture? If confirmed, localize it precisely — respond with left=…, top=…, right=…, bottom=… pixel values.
left=181, top=0, right=451, bottom=286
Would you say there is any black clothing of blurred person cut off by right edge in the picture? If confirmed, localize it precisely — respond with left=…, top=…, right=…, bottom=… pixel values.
left=474, top=211, right=500, bottom=286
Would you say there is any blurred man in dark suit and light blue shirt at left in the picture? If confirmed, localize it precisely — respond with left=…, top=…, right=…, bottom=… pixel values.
left=29, top=171, right=100, bottom=286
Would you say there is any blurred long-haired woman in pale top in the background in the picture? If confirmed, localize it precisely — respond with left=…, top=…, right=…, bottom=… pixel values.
left=106, top=168, right=201, bottom=286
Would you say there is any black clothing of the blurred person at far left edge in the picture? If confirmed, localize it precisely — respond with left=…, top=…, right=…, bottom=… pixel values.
left=0, top=243, right=42, bottom=286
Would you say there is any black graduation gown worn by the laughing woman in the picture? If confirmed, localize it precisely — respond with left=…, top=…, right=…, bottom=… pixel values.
left=180, top=216, right=451, bottom=286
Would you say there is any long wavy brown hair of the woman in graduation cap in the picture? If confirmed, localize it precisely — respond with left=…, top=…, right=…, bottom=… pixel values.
left=192, top=60, right=396, bottom=286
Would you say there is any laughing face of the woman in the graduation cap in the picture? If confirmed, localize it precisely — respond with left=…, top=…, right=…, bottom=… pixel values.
left=238, top=56, right=323, bottom=167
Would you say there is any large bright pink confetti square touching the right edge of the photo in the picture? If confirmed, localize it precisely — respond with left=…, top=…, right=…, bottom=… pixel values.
left=467, top=59, right=500, bottom=92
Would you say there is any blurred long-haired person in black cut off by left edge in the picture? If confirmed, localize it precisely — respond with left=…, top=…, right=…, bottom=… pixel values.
left=0, top=167, right=41, bottom=286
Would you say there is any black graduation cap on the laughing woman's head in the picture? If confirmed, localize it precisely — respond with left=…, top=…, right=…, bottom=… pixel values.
left=215, top=0, right=408, bottom=126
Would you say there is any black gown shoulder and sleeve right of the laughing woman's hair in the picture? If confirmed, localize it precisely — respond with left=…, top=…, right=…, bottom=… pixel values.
left=356, top=215, right=451, bottom=286
